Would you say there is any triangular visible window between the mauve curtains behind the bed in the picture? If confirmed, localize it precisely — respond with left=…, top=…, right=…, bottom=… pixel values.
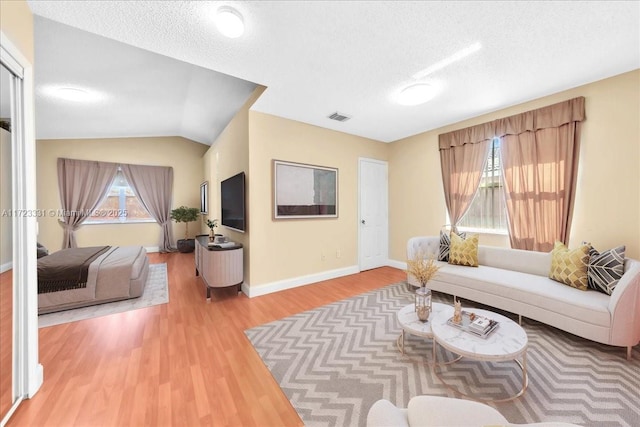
left=85, top=169, right=155, bottom=224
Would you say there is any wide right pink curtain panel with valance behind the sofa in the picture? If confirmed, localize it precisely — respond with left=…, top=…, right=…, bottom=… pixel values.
left=497, top=97, right=585, bottom=252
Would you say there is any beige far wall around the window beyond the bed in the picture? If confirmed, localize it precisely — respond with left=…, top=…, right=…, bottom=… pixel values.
left=36, top=137, right=208, bottom=251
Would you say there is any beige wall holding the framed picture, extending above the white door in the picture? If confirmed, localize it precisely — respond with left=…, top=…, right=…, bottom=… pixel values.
left=249, top=111, right=389, bottom=286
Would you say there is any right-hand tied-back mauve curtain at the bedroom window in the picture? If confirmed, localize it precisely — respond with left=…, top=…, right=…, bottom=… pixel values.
left=121, top=165, right=175, bottom=252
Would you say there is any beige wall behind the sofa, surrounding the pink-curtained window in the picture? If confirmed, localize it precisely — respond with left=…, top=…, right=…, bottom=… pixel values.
left=389, top=70, right=640, bottom=261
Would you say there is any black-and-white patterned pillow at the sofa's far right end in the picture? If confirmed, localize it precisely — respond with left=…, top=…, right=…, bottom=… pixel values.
left=587, top=246, right=626, bottom=295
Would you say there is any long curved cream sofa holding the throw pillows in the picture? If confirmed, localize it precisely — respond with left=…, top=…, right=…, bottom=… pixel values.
left=407, top=236, right=640, bottom=359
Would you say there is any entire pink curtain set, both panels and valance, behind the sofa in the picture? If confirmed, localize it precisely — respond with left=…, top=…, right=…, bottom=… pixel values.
left=439, top=97, right=585, bottom=251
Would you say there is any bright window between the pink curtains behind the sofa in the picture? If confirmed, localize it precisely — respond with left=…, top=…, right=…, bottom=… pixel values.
left=458, top=138, right=507, bottom=233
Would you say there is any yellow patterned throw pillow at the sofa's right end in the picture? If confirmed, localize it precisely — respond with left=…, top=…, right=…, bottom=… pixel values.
left=549, top=242, right=589, bottom=291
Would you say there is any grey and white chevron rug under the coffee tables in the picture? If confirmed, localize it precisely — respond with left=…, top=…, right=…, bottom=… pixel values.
left=245, top=282, right=640, bottom=427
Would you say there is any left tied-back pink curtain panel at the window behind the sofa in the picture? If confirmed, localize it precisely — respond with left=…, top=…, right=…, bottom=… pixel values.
left=439, top=125, right=493, bottom=231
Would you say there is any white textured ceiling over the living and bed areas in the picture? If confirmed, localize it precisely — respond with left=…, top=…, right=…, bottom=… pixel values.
left=28, top=0, right=640, bottom=144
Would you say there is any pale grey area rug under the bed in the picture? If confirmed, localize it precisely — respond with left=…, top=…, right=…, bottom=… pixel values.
left=38, top=264, right=169, bottom=328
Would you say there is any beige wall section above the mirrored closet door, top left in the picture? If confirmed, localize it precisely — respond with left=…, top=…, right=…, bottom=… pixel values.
left=0, top=0, right=34, bottom=64
